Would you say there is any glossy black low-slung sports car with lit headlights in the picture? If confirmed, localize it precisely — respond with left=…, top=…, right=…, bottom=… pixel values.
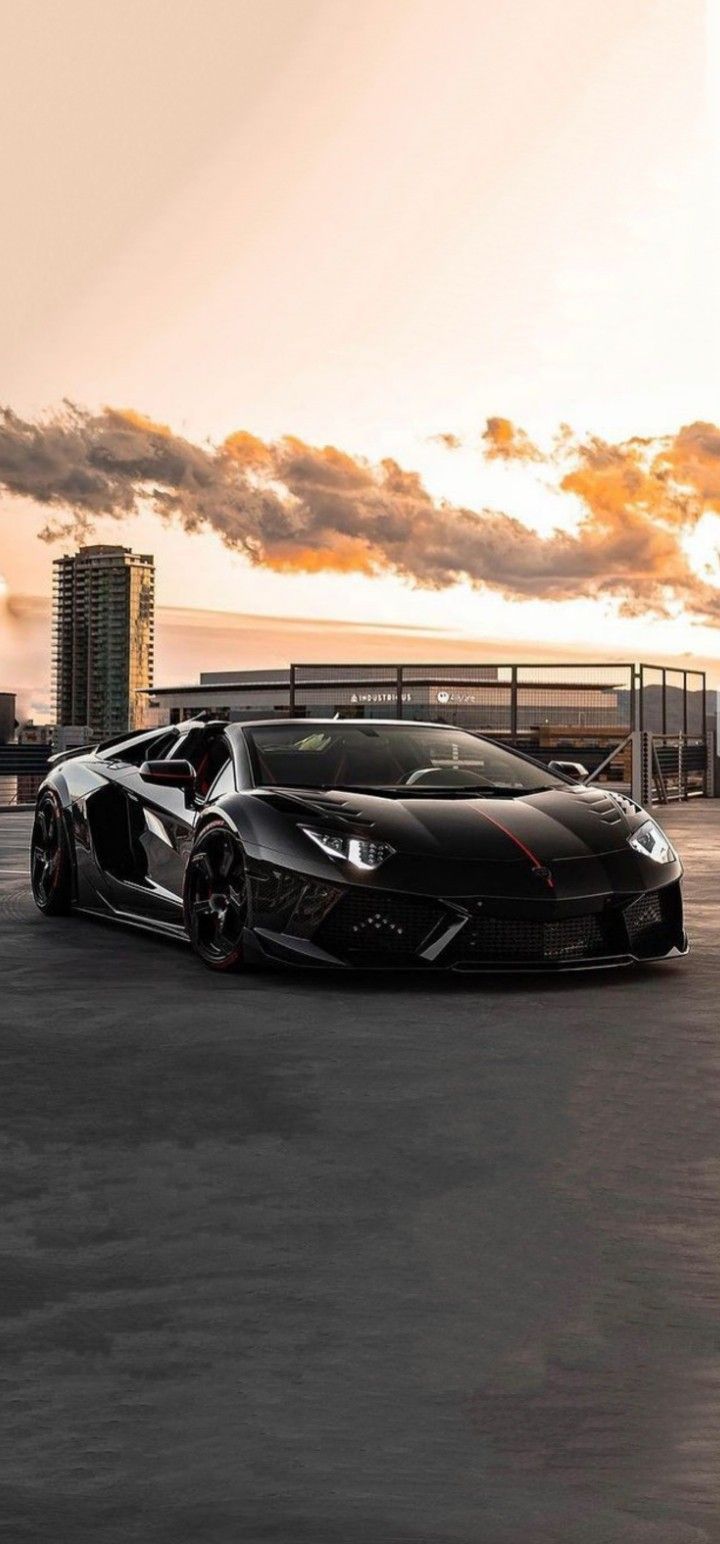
left=31, top=718, right=688, bottom=971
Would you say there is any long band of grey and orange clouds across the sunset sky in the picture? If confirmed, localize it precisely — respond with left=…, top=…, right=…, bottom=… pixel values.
left=0, top=405, right=720, bottom=618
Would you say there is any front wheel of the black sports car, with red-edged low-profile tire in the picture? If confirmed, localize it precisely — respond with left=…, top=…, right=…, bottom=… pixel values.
left=184, top=820, right=247, bottom=970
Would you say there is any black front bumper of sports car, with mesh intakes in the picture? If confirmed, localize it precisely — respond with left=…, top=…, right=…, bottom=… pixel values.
left=247, top=862, right=688, bottom=973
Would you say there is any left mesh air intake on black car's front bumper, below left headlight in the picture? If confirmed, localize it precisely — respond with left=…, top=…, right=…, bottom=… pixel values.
left=314, top=891, right=448, bottom=957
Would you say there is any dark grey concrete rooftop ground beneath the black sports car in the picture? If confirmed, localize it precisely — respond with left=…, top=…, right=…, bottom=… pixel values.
left=0, top=803, right=720, bottom=1544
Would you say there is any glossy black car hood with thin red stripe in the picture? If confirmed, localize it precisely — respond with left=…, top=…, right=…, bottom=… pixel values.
left=262, top=787, right=636, bottom=865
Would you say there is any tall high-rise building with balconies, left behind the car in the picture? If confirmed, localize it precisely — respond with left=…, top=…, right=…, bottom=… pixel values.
left=53, top=545, right=155, bottom=736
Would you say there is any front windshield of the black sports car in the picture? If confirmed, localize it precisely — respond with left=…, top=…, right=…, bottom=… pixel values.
left=246, top=723, right=567, bottom=795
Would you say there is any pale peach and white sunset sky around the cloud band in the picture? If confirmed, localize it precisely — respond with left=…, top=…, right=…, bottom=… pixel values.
left=0, top=0, right=720, bottom=707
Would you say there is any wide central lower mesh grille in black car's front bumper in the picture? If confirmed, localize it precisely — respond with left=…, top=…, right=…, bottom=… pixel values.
left=459, top=913, right=612, bottom=963
